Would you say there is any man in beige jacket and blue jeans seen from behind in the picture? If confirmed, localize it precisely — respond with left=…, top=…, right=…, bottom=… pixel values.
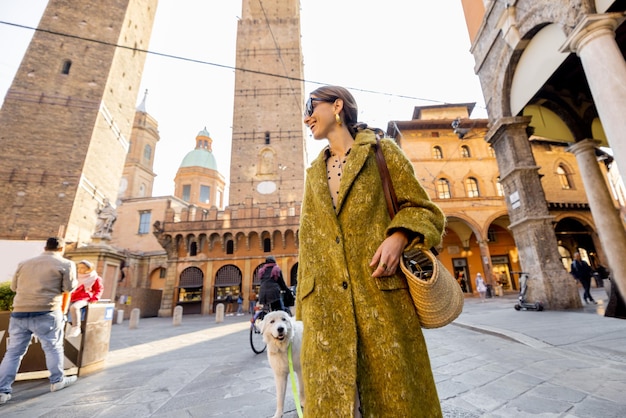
left=0, top=237, right=78, bottom=405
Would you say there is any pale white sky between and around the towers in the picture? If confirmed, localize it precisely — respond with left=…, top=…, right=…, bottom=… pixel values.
left=0, top=0, right=486, bottom=196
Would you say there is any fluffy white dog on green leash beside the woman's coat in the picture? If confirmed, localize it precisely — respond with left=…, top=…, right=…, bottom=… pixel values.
left=261, top=311, right=304, bottom=418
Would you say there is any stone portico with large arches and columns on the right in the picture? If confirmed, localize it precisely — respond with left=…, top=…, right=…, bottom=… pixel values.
left=461, top=0, right=626, bottom=309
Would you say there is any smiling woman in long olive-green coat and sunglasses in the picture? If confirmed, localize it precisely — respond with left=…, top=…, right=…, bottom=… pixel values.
left=296, top=86, right=445, bottom=417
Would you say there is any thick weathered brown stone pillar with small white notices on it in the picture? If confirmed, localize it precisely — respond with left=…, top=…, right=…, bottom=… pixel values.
left=485, top=117, right=582, bottom=309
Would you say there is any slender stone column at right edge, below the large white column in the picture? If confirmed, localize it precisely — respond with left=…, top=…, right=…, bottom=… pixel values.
left=569, top=139, right=626, bottom=295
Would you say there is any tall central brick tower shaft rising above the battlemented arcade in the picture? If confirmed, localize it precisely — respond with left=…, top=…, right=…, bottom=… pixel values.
left=229, top=0, right=306, bottom=205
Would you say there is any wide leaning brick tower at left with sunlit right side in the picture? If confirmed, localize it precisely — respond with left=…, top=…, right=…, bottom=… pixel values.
left=0, top=0, right=157, bottom=243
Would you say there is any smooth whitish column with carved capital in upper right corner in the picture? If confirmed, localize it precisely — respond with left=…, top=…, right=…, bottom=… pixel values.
left=561, top=12, right=626, bottom=184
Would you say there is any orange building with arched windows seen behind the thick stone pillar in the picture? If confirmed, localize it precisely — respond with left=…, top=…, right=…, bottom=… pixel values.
left=387, top=103, right=617, bottom=294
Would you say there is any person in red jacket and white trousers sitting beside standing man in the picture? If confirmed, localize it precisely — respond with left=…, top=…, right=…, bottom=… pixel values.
left=67, top=260, right=104, bottom=337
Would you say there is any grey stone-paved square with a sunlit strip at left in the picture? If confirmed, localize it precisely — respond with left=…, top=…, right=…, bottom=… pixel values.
left=0, top=288, right=626, bottom=418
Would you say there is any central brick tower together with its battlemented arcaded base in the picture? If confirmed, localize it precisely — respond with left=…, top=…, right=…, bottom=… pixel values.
left=155, top=0, right=306, bottom=316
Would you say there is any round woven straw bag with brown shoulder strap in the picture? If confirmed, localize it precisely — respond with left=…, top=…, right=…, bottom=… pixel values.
left=375, top=139, right=465, bottom=328
